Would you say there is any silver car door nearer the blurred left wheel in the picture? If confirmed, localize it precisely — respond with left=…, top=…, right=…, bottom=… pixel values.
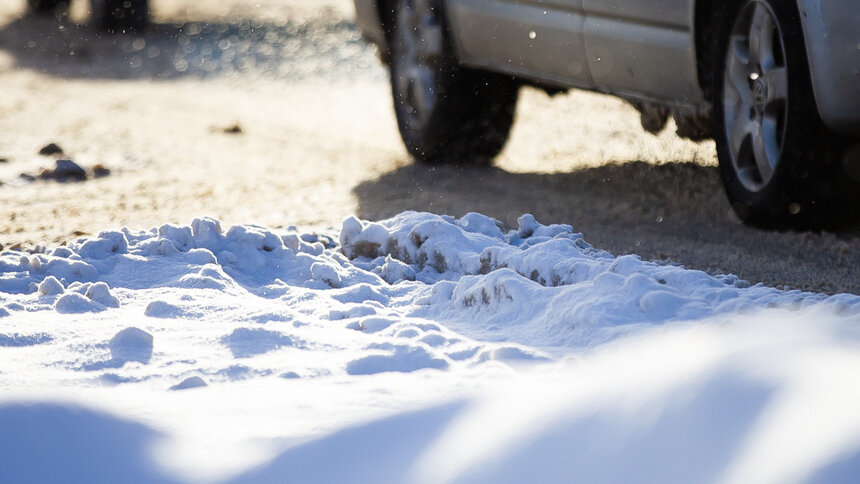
left=446, top=0, right=591, bottom=88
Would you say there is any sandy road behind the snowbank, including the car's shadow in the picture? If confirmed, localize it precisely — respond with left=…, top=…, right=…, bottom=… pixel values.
left=0, top=0, right=860, bottom=293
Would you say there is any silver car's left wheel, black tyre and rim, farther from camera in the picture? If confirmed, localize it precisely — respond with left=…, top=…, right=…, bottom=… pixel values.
left=388, top=0, right=519, bottom=165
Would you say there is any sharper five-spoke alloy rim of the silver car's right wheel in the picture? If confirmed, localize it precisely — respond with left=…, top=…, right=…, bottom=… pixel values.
left=723, top=0, right=788, bottom=192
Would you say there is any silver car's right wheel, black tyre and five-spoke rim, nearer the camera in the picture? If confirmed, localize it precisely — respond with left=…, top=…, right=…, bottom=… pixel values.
left=713, top=0, right=847, bottom=228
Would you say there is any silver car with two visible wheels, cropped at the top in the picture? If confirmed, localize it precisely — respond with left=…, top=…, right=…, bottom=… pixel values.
left=355, top=0, right=860, bottom=226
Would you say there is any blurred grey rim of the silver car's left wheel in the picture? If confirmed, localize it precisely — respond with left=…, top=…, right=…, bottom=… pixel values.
left=393, top=0, right=442, bottom=129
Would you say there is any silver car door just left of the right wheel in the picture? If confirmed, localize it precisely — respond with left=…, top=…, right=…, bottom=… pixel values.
left=582, top=0, right=701, bottom=105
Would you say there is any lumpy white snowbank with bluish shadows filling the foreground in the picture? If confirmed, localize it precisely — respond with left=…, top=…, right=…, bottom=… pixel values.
left=0, top=212, right=860, bottom=483
